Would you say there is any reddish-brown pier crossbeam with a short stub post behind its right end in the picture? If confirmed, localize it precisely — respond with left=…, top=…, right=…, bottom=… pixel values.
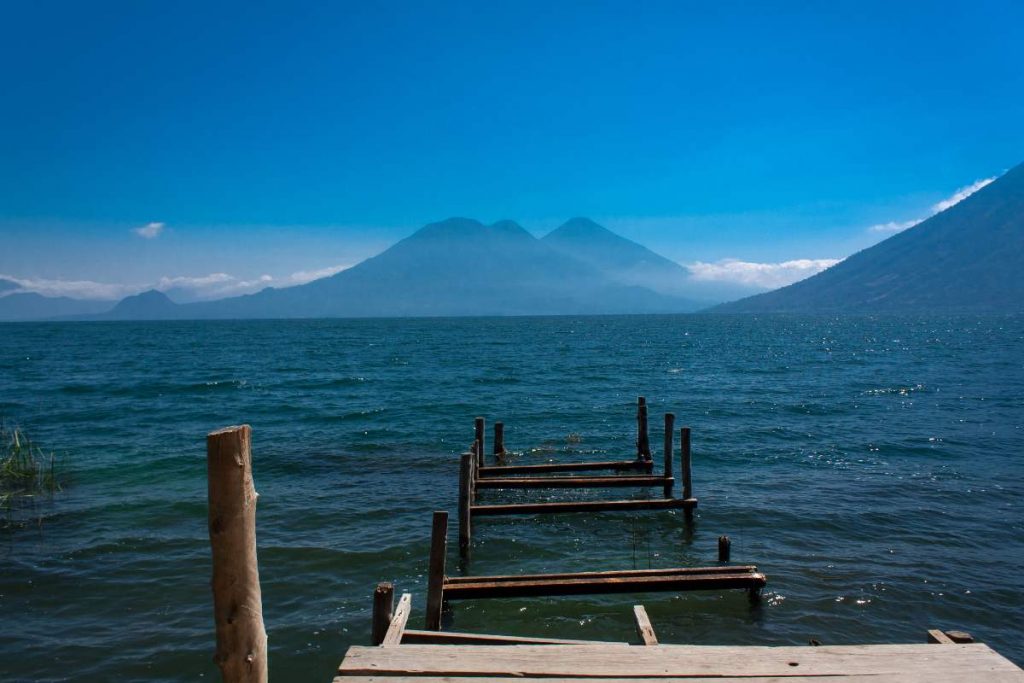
left=444, top=571, right=767, bottom=600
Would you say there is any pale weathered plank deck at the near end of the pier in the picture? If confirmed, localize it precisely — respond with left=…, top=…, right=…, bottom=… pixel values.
left=334, top=643, right=1024, bottom=683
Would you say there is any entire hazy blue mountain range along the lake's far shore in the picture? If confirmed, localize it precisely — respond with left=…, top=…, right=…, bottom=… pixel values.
left=0, top=165, right=1024, bottom=319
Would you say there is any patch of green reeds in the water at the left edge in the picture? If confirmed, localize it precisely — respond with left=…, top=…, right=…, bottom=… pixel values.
left=0, top=421, right=67, bottom=527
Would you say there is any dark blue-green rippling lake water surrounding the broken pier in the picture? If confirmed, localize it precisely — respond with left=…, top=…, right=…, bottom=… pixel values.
left=0, top=316, right=1024, bottom=681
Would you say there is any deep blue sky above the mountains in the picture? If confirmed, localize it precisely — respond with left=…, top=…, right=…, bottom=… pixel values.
left=0, top=1, right=1024, bottom=296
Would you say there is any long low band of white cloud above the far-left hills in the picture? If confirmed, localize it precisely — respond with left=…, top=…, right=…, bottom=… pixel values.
left=0, top=264, right=350, bottom=301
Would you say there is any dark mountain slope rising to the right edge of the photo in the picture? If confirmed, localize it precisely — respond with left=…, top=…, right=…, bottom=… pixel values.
left=713, top=165, right=1024, bottom=312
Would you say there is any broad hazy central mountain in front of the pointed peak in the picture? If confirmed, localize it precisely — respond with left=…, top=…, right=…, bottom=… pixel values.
left=86, top=218, right=697, bottom=319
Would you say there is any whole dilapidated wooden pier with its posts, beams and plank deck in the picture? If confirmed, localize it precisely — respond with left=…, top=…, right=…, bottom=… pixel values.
left=197, top=421, right=1024, bottom=683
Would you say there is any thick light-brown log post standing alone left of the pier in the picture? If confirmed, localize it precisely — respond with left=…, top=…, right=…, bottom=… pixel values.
left=206, top=425, right=267, bottom=683
